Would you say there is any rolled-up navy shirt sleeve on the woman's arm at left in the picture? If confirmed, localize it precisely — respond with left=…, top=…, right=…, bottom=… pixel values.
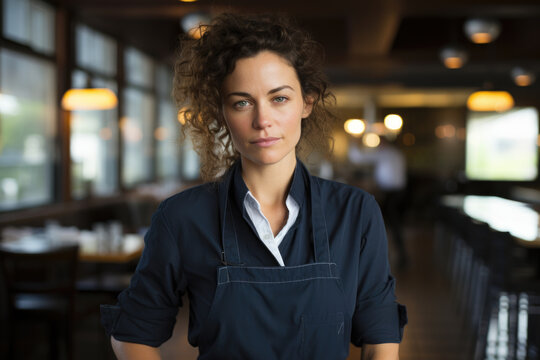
left=101, top=202, right=186, bottom=347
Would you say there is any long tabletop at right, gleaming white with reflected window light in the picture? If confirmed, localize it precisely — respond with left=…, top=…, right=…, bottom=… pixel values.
left=441, top=195, right=540, bottom=248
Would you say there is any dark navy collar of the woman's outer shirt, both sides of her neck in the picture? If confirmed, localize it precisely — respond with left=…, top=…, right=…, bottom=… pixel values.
left=232, top=159, right=308, bottom=213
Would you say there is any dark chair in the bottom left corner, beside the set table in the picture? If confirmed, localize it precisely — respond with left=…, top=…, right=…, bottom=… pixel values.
left=0, top=244, right=78, bottom=359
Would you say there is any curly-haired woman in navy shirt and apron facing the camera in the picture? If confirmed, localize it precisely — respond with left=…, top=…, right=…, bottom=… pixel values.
left=102, top=15, right=406, bottom=359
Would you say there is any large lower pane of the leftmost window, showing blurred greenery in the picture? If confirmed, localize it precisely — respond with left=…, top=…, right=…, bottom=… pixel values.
left=0, top=50, right=56, bottom=210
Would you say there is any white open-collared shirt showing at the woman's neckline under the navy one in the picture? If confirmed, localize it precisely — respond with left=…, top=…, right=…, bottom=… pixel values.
left=244, top=191, right=300, bottom=266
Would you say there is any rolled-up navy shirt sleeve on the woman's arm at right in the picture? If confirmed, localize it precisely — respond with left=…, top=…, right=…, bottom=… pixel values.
left=351, top=196, right=407, bottom=346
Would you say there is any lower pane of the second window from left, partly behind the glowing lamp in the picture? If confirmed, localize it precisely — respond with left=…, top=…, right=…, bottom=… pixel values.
left=70, top=71, right=118, bottom=198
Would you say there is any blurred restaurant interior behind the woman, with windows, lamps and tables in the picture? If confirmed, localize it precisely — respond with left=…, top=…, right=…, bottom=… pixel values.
left=0, top=0, right=540, bottom=360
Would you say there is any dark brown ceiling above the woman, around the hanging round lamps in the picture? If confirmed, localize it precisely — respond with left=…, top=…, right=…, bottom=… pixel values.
left=56, top=0, right=540, bottom=106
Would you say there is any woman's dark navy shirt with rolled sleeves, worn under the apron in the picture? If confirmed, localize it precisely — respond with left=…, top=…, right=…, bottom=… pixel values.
left=102, top=161, right=407, bottom=346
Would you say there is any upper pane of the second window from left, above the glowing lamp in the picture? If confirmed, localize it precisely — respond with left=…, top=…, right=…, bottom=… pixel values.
left=75, top=25, right=116, bottom=76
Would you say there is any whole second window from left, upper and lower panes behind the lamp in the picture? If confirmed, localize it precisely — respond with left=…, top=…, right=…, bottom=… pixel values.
left=70, top=24, right=119, bottom=199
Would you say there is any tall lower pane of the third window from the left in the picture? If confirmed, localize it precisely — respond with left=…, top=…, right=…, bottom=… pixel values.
left=120, top=88, right=155, bottom=187
